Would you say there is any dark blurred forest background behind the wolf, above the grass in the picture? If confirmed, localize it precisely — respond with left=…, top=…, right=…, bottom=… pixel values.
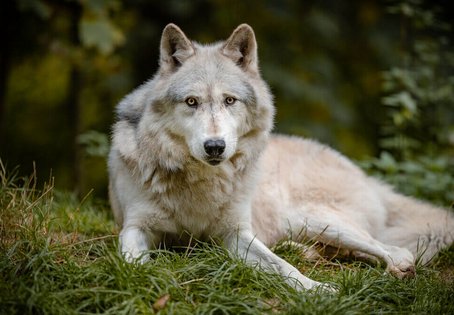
left=0, top=0, right=454, bottom=206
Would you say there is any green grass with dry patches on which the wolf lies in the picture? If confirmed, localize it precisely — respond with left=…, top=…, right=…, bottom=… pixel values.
left=0, top=165, right=454, bottom=314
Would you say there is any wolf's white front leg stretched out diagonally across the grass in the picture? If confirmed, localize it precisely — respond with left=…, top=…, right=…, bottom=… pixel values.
left=224, top=231, right=325, bottom=290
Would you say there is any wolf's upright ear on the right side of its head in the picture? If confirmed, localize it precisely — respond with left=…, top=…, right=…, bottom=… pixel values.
left=222, top=24, right=258, bottom=72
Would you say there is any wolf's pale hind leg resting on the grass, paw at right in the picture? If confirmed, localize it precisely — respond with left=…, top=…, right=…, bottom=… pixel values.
left=289, top=205, right=415, bottom=278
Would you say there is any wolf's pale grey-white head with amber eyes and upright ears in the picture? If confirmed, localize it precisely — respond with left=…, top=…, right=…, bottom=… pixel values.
left=131, top=24, right=274, bottom=170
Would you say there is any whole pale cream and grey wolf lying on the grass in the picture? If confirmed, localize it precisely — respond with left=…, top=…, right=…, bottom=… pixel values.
left=108, top=24, right=454, bottom=289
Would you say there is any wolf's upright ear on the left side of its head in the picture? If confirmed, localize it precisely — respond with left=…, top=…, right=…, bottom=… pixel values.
left=159, top=24, right=194, bottom=71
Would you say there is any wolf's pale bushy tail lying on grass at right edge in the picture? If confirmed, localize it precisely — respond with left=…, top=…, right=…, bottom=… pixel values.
left=376, top=179, right=454, bottom=264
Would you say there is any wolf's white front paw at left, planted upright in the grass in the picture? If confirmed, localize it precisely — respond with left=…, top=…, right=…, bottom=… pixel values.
left=120, top=226, right=159, bottom=263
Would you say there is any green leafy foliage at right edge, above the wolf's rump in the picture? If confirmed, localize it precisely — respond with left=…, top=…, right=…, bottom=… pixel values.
left=362, top=0, right=454, bottom=206
